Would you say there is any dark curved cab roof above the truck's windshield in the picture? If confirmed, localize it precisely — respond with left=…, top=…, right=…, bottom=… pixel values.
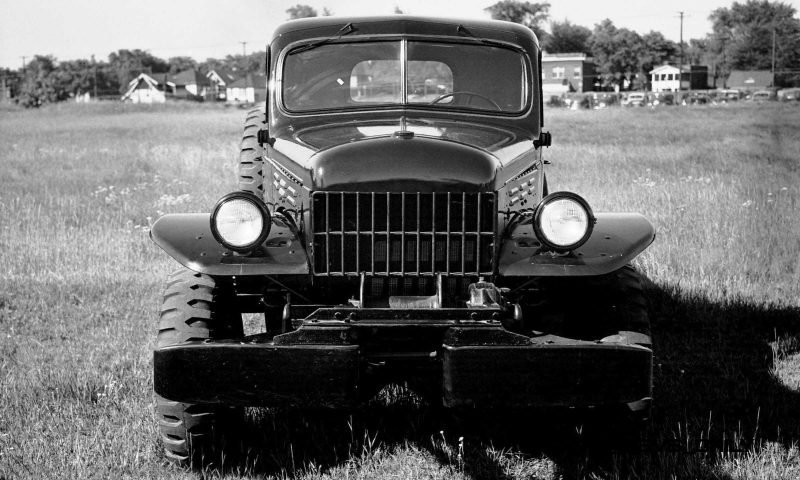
left=270, top=15, right=539, bottom=53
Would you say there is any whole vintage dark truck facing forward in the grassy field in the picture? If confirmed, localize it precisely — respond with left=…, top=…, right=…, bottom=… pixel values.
left=151, top=16, right=655, bottom=465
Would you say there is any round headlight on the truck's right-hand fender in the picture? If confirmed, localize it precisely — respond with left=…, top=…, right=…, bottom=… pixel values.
left=533, top=192, right=595, bottom=252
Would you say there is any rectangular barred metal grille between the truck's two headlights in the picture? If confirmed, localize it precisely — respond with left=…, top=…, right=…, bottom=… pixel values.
left=311, top=192, right=497, bottom=276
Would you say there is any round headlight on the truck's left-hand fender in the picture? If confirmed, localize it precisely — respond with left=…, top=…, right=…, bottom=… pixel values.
left=211, top=192, right=272, bottom=252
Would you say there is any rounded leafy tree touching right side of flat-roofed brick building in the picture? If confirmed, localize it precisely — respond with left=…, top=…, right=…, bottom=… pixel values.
left=589, top=19, right=643, bottom=89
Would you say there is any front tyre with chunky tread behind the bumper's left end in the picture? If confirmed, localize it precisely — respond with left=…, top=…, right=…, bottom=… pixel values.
left=156, top=270, right=242, bottom=467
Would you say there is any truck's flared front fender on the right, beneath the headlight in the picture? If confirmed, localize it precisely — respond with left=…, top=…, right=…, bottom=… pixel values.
left=498, top=213, right=656, bottom=277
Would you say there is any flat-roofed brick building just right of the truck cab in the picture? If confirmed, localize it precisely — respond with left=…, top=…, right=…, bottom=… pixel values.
left=542, top=53, right=597, bottom=95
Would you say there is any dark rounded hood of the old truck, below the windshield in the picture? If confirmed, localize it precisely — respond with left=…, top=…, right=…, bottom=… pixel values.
left=276, top=120, right=532, bottom=192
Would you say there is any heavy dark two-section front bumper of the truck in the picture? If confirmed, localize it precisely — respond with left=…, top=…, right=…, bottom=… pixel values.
left=154, top=314, right=653, bottom=408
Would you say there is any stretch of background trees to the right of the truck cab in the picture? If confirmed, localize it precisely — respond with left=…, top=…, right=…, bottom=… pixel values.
left=486, top=0, right=800, bottom=89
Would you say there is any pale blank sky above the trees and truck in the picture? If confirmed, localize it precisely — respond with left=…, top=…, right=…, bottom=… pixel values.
left=0, top=0, right=800, bottom=69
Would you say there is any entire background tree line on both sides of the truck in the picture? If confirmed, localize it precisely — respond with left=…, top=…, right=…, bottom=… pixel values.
left=0, top=0, right=800, bottom=106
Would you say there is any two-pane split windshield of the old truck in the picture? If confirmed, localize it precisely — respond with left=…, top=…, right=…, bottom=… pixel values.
left=282, top=40, right=529, bottom=113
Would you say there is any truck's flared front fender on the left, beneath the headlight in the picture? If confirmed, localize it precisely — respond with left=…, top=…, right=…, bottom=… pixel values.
left=150, top=213, right=308, bottom=276
